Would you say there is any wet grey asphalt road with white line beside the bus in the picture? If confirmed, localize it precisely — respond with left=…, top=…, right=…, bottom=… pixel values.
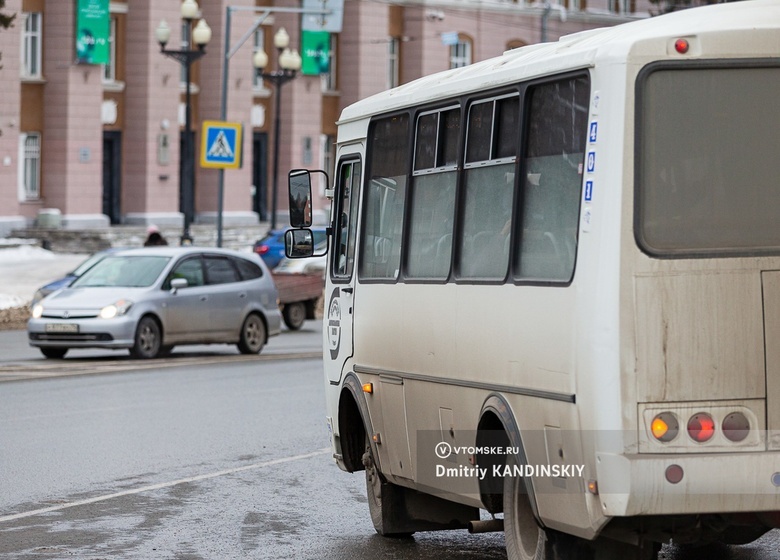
left=0, top=323, right=780, bottom=560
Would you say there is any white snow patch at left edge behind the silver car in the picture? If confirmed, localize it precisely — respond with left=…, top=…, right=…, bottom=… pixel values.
left=0, top=243, right=89, bottom=309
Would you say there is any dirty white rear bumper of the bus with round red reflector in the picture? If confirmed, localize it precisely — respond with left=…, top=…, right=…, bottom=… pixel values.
left=596, top=451, right=780, bottom=517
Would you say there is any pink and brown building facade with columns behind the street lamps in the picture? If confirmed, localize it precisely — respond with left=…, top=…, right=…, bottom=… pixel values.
left=0, top=0, right=651, bottom=236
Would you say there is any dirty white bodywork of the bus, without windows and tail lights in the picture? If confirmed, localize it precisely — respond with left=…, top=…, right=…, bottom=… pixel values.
left=316, top=1, right=780, bottom=548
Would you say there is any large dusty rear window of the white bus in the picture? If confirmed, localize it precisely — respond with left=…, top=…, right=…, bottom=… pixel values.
left=635, top=65, right=780, bottom=257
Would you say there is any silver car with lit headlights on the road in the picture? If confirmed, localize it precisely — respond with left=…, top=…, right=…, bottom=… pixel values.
left=27, top=247, right=281, bottom=358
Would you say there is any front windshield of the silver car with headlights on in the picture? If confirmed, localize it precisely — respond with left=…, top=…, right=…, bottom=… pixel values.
left=71, top=255, right=171, bottom=288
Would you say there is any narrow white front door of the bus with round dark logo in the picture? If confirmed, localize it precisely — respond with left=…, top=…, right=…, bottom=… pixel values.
left=325, top=156, right=362, bottom=383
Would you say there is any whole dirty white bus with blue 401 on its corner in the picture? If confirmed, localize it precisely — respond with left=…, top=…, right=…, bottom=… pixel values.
left=288, top=0, right=780, bottom=560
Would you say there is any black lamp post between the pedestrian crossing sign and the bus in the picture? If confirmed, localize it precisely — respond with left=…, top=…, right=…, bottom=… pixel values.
left=252, top=27, right=301, bottom=230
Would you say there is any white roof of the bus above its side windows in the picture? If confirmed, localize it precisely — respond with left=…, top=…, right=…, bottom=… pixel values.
left=339, top=0, right=780, bottom=124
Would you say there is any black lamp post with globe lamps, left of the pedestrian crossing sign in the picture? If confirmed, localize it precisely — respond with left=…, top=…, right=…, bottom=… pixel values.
left=156, top=0, right=211, bottom=245
